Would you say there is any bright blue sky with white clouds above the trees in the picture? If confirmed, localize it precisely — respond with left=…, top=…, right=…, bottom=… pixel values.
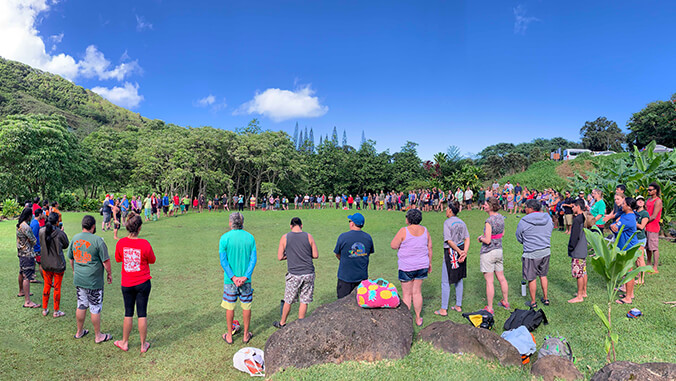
left=0, top=0, right=676, bottom=159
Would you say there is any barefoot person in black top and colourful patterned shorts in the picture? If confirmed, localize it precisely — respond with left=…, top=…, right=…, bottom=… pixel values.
left=568, top=199, right=587, bottom=303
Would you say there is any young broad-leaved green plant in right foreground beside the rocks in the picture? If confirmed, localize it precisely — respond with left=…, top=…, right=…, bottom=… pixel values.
left=584, top=226, right=653, bottom=363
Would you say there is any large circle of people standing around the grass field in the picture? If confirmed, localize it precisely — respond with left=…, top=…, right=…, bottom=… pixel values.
left=16, top=182, right=662, bottom=352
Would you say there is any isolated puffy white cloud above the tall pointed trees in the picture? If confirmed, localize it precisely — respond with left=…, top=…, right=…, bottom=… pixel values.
left=235, top=85, right=329, bottom=122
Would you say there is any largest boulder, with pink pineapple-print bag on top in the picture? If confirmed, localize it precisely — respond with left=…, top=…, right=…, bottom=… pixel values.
left=265, top=291, right=413, bottom=375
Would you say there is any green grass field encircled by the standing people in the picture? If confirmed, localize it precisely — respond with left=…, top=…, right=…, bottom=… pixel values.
left=0, top=210, right=676, bottom=380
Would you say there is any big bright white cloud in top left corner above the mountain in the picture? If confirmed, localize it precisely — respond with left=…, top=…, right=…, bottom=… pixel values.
left=0, top=0, right=140, bottom=81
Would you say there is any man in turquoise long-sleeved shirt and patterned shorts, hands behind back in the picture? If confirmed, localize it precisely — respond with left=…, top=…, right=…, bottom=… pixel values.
left=218, top=212, right=256, bottom=344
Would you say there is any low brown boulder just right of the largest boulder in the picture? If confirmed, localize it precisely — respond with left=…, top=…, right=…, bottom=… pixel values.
left=418, top=320, right=521, bottom=366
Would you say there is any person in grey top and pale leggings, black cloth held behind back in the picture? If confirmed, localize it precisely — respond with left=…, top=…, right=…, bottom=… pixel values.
left=434, top=201, right=470, bottom=316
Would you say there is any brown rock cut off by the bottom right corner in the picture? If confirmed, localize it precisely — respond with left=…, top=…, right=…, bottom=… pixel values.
left=591, top=361, right=676, bottom=381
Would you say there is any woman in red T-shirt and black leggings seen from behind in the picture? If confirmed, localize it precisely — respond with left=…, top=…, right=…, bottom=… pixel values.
left=115, top=212, right=155, bottom=353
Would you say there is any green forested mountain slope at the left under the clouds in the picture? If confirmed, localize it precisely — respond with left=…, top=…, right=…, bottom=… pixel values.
left=0, top=57, right=150, bottom=137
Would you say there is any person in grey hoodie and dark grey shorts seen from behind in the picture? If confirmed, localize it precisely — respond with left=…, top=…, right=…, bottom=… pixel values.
left=516, top=200, right=554, bottom=308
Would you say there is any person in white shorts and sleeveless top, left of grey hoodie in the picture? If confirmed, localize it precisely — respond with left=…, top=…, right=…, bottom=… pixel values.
left=477, top=197, right=509, bottom=313
